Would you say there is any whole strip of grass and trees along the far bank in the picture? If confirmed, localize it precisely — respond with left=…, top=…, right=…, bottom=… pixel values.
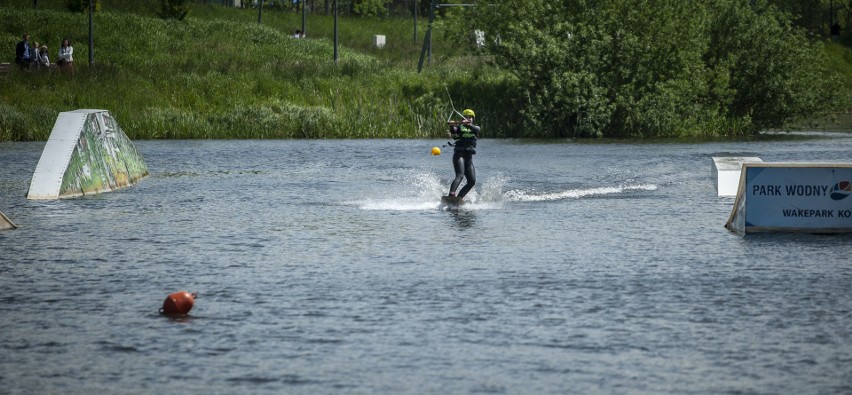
left=0, top=0, right=852, bottom=141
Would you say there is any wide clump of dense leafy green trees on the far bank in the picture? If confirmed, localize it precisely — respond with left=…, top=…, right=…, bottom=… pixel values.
left=472, top=0, right=844, bottom=137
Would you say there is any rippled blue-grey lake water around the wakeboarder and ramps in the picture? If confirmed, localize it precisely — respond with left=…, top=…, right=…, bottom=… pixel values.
left=0, top=135, right=852, bottom=394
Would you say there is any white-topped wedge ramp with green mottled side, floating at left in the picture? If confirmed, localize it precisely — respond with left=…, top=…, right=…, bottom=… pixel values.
left=27, top=110, right=148, bottom=199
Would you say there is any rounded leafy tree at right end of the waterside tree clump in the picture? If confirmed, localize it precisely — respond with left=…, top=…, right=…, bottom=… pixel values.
left=705, top=0, right=841, bottom=129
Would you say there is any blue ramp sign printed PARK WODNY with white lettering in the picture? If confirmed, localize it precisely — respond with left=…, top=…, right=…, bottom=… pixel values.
left=726, top=163, right=852, bottom=234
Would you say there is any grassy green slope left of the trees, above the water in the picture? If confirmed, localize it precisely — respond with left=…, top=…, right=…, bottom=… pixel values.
left=0, top=6, right=524, bottom=140
